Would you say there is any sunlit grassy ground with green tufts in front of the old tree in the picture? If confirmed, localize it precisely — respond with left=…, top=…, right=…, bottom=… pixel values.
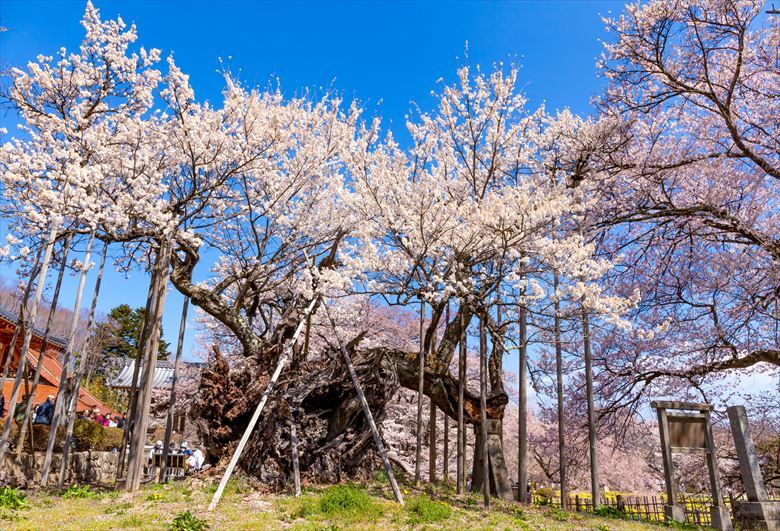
left=0, top=478, right=704, bottom=531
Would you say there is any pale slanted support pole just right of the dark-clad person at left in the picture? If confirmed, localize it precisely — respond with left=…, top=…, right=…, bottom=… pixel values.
left=41, top=230, right=95, bottom=487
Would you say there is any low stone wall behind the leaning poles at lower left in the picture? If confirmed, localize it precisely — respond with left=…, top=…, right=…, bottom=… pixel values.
left=3, top=451, right=119, bottom=487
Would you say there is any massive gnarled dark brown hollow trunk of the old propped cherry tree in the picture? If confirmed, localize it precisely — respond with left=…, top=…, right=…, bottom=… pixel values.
left=193, top=304, right=508, bottom=489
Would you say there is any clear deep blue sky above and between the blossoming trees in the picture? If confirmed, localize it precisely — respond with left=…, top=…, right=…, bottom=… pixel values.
left=0, top=0, right=623, bottom=367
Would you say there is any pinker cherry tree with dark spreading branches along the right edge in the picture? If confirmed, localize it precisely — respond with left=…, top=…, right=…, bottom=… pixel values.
left=571, top=0, right=780, bottom=420
